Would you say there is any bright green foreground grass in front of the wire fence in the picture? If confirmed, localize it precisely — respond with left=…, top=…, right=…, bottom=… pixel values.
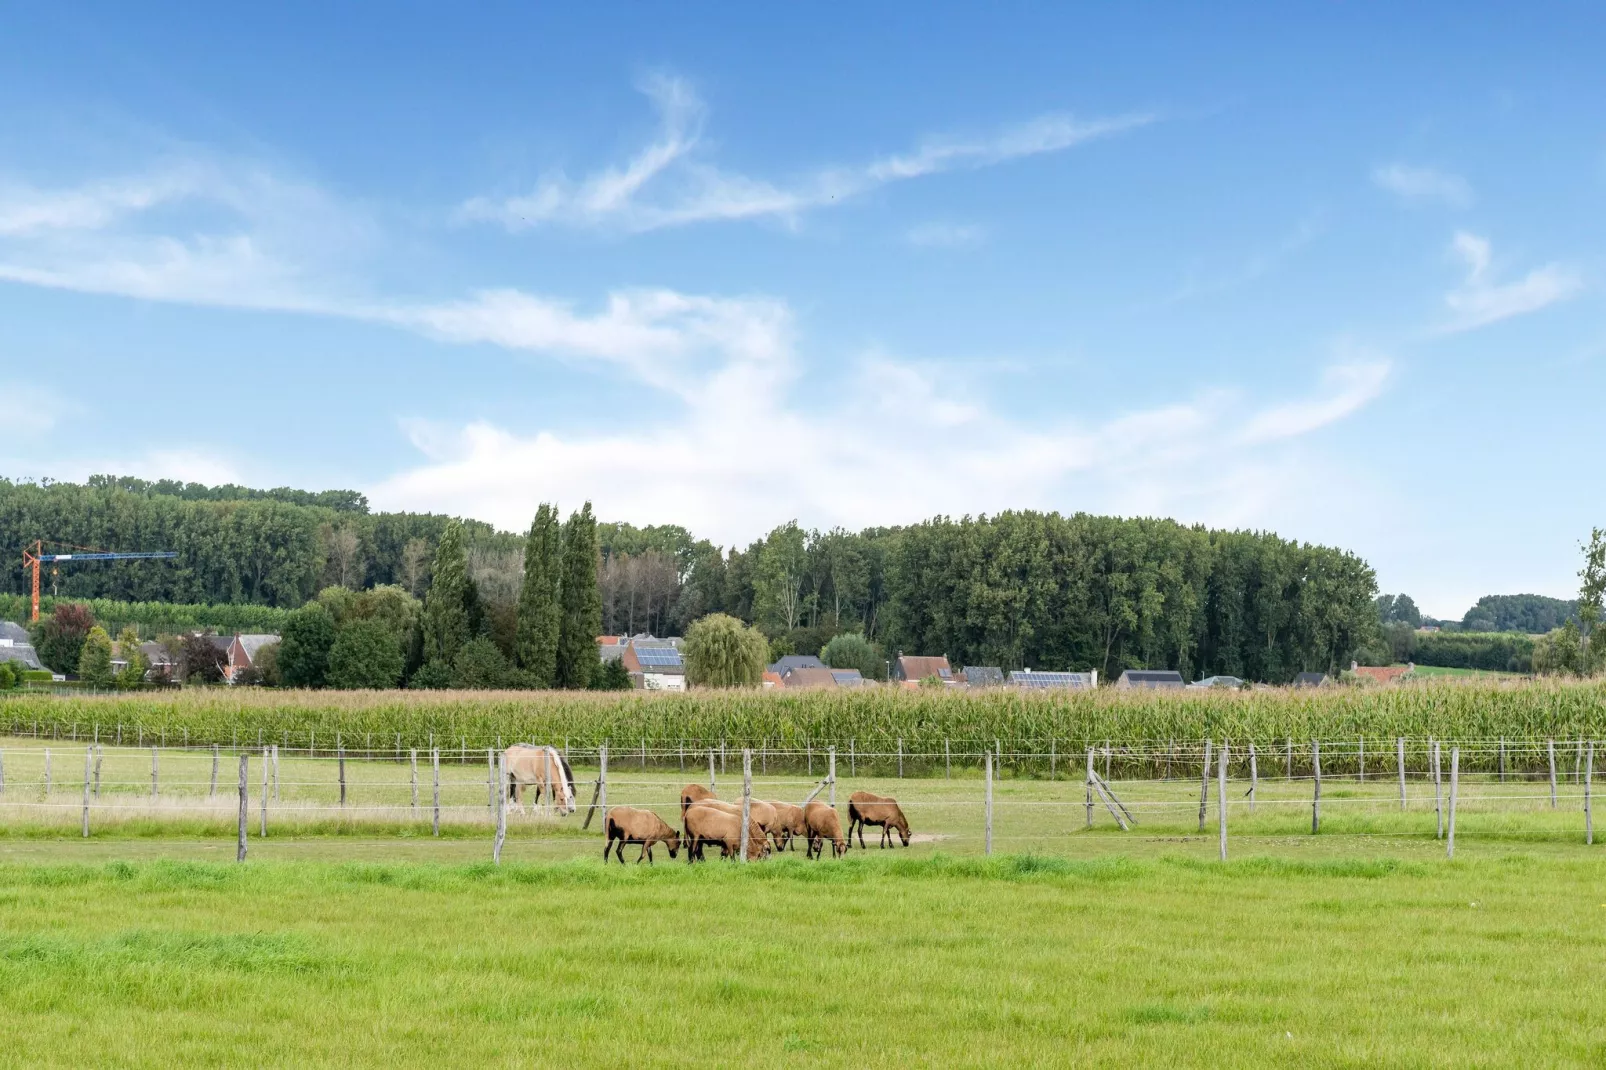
left=0, top=840, right=1606, bottom=1067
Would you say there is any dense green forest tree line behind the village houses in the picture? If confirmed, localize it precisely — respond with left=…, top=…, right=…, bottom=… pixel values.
left=0, top=477, right=1380, bottom=683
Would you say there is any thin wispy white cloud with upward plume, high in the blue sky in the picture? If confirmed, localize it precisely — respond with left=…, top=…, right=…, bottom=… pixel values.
left=459, top=77, right=1153, bottom=231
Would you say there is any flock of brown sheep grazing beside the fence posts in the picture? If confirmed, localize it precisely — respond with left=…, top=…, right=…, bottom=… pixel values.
left=602, top=784, right=909, bottom=864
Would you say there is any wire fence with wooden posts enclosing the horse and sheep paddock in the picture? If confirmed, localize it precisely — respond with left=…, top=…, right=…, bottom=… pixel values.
left=0, top=733, right=1595, bottom=860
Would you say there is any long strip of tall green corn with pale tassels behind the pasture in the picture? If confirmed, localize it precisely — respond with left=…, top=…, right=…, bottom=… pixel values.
left=9, top=680, right=1606, bottom=763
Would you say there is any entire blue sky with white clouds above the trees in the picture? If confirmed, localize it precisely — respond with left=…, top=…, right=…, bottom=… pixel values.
left=0, top=3, right=1606, bottom=617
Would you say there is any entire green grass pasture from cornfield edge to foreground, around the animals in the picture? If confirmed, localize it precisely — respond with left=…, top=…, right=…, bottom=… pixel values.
left=0, top=739, right=1606, bottom=1067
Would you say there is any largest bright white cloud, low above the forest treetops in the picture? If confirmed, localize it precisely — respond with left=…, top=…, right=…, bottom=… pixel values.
left=369, top=282, right=1388, bottom=541
